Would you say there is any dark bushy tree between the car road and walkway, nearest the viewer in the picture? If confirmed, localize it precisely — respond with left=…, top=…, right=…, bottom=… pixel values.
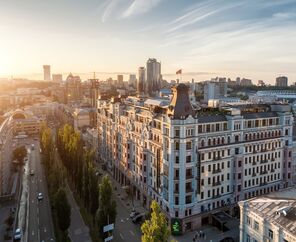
left=54, top=188, right=71, bottom=232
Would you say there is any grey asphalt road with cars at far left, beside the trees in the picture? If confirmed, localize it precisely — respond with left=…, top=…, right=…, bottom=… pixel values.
left=27, top=140, right=54, bottom=242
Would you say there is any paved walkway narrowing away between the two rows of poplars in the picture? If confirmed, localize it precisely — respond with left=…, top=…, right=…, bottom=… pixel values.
left=66, top=185, right=91, bottom=242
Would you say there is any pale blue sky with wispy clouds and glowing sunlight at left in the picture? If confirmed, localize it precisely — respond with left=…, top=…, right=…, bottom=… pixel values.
left=0, top=0, right=296, bottom=83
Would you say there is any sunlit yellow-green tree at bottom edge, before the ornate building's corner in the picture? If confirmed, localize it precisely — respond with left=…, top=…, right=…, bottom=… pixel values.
left=141, top=200, right=170, bottom=242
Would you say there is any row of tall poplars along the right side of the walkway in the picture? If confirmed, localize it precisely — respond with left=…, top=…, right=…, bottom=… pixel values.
left=57, top=124, right=116, bottom=238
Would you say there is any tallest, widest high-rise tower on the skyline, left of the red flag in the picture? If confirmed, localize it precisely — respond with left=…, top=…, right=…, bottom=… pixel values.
left=146, top=58, right=161, bottom=95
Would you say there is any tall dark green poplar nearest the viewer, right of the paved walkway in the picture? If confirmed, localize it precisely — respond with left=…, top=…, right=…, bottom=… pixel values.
left=96, top=175, right=116, bottom=238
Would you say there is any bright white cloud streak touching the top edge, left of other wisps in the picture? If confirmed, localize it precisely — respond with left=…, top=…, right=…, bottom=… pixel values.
left=122, top=0, right=162, bottom=18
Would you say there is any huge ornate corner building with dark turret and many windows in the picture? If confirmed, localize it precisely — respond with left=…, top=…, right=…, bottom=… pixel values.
left=97, top=84, right=292, bottom=232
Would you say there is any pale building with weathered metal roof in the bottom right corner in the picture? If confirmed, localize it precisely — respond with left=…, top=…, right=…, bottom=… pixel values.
left=239, top=187, right=296, bottom=242
